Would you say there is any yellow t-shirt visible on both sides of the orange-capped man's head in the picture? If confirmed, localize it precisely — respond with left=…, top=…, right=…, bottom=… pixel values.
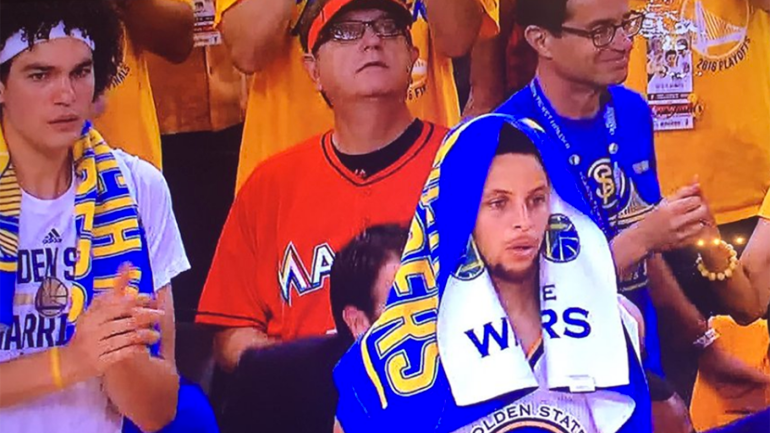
left=217, top=0, right=499, bottom=188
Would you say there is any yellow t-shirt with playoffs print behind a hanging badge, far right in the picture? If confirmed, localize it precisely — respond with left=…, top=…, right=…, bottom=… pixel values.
left=627, top=0, right=770, bottom=224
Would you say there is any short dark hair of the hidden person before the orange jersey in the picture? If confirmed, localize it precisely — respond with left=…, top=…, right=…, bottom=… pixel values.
left=330, top=224, right=409, bottom=340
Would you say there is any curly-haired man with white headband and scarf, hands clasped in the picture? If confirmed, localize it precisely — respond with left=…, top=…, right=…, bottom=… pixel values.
left=0, top=0, right=189, bottom=433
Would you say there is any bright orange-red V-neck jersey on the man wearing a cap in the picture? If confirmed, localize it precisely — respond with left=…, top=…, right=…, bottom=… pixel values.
left=197, top=122, right=447, bottom=341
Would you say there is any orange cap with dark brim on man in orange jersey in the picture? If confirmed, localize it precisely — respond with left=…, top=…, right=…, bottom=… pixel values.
left=300, top=0, right=414, bottom=52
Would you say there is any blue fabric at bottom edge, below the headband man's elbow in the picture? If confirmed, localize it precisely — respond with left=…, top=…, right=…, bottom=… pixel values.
left=123, top=379, right=219, bottom=433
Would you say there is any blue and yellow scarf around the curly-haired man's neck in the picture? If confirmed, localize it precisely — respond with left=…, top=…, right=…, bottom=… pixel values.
left=0, top=123, right=153, bottom=339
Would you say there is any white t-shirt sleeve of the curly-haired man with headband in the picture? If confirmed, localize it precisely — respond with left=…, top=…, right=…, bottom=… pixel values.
left=113, top=150, right=190, bottom=291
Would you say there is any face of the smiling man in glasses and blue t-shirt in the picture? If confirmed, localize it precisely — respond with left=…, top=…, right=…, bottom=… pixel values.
left=549, top=0, right=632, bottom=86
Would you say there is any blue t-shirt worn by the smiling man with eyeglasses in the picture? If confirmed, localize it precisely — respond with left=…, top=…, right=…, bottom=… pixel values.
left=496, top=84, right=663, bottom=375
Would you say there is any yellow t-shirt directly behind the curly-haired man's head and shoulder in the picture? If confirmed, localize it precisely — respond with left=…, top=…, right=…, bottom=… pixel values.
left=94, top=0, right=192, bottom=169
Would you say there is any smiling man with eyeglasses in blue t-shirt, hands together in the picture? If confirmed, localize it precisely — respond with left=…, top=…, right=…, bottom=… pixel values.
left=498, top=0, right=768, bottom=414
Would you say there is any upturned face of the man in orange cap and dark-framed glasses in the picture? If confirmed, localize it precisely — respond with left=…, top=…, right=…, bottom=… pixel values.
left=306, top=9, right=417, bottom=105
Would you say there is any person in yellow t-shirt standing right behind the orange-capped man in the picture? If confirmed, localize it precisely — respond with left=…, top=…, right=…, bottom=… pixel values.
left=216, top=0, right=498, bottom=193
